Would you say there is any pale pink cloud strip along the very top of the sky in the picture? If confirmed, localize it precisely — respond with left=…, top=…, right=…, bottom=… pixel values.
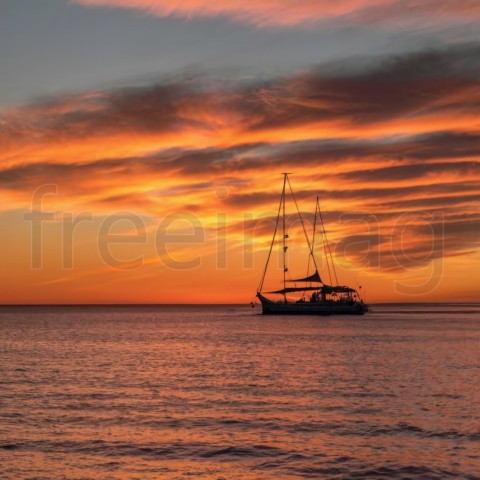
left=73, top=0, right=480, bottom=27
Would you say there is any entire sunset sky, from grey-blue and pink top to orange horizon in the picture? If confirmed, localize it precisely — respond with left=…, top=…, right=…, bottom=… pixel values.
left=0, top=0, right=480, bottom=304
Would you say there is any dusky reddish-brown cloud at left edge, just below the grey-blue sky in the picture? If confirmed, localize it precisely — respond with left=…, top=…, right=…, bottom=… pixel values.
left=0, top=81, right=209, bottom=146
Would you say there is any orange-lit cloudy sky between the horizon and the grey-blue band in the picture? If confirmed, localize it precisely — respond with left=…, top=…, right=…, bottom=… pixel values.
left=0, top=1, right=480, bottom=304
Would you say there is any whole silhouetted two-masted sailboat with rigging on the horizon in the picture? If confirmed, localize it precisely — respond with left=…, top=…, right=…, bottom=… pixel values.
left=257, top=173, right=368, bottom=315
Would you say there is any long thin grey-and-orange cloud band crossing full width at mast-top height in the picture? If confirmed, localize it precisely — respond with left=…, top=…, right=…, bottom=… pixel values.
left=0, top=134, right=479, bottom=207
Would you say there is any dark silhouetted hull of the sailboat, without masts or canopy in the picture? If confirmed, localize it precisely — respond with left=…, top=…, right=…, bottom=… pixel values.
left=257, top=293, right=368, bottom=315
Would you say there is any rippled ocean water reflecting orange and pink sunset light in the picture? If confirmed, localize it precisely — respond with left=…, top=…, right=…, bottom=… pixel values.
left=0, top=304, right=480, bottom=480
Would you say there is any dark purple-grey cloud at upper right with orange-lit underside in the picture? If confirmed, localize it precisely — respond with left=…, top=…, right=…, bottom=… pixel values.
left=246, top=45, right=480, bottom=133
